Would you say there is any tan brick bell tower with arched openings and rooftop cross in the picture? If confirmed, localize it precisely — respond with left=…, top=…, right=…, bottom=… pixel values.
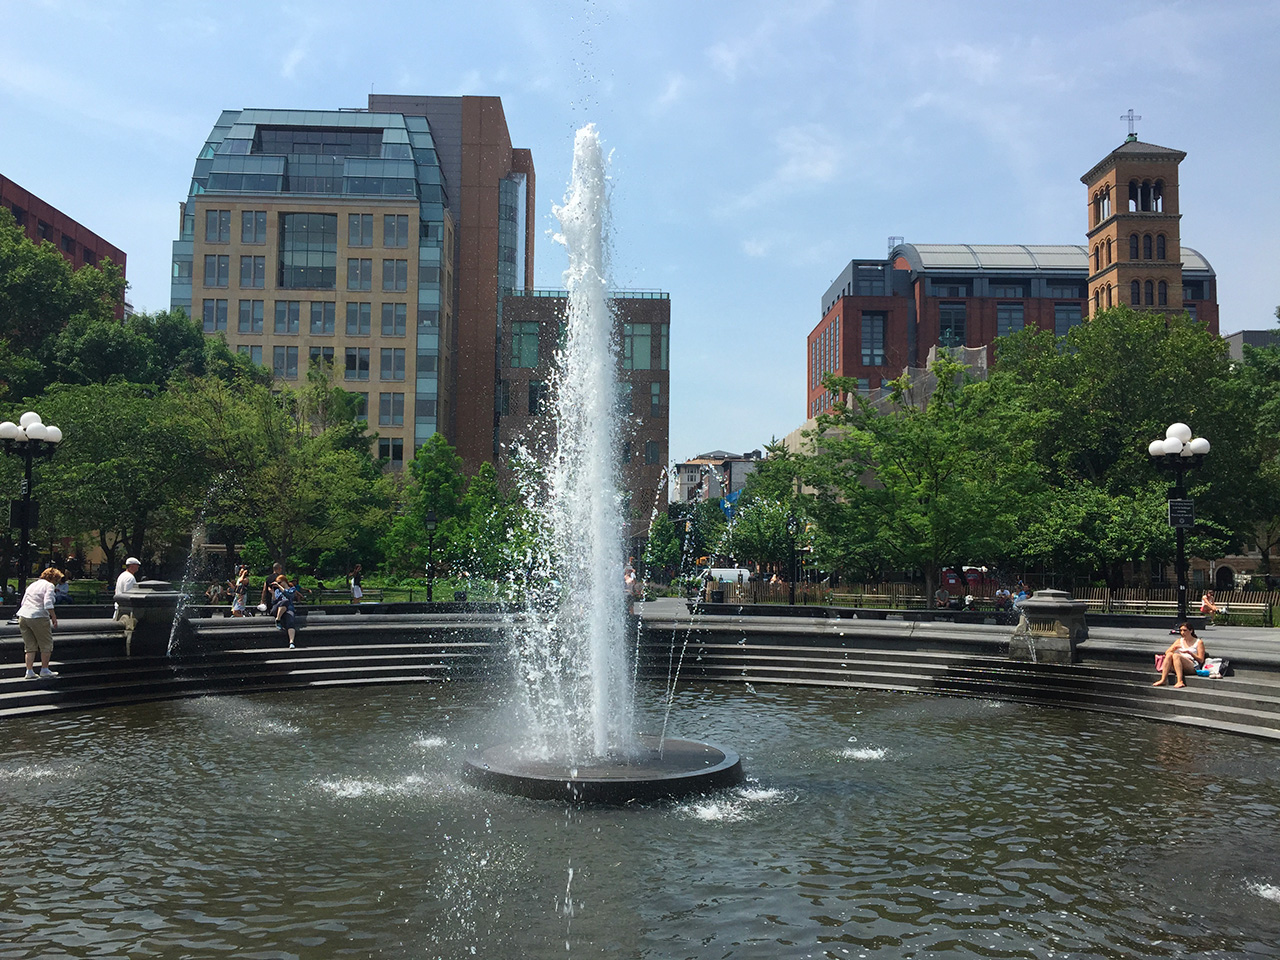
left=1080, top=110, right=1187, bottom=316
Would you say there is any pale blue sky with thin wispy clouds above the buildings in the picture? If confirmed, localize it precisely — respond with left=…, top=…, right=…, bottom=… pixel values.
left=0, top=0, right=1280, bottom=461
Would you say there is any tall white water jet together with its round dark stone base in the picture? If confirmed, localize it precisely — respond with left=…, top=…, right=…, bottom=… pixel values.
left=465, top=124, right=742, bottom=803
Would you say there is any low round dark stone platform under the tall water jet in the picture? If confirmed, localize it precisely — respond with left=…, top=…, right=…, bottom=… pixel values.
left=462, top=736, right=742, bottom=804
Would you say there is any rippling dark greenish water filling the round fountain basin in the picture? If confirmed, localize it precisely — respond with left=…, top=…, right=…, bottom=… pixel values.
left=0, top=684, right=1280, bottom=960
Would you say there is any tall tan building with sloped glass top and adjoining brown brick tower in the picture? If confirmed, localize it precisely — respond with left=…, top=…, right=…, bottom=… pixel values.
left=170, top=97, right=532, bottom=468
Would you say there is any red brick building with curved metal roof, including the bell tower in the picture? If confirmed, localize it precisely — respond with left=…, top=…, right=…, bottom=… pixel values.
left=805, top=137, right=1219, bottom=417
